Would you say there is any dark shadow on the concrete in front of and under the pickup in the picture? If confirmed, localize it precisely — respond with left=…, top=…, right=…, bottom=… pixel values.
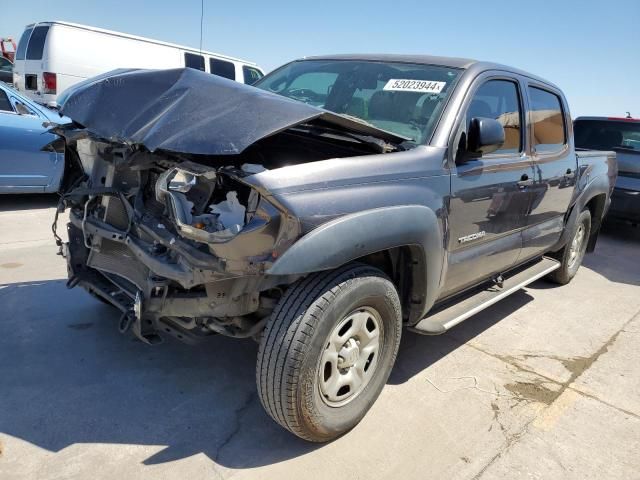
left=0, top=280, right=531, bottom=468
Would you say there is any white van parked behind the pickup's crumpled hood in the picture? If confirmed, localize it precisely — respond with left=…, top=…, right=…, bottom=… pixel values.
left=13, top=21, right=264, bottom=106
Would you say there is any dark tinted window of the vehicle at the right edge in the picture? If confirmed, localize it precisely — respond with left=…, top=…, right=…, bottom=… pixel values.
left=574, top=120, right=640, bottom=152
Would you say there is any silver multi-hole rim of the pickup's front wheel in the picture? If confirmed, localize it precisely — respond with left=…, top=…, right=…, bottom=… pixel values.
left=317, top=306, right=383, bottom=407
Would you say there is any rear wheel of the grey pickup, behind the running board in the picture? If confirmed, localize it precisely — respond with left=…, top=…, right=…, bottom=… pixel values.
left=547, top=210, right=591, bottom=285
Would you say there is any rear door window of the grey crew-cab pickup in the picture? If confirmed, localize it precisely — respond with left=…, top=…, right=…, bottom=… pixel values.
left=529, top=87, right=566, bottom=153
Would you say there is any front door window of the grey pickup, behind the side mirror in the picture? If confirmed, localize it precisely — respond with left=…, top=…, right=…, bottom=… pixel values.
left=467, top=80, right=522, bottom=154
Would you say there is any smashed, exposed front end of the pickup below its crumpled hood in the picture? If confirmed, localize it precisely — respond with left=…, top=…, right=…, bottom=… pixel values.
left=58, top=137, right=372, bottom=341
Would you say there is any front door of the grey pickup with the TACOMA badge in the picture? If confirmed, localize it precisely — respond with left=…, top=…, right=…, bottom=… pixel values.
left=442, top=74, right=532, bottom=297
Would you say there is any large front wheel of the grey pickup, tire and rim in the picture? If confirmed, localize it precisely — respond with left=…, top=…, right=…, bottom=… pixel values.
left=256, top=264, right=402, bottom=442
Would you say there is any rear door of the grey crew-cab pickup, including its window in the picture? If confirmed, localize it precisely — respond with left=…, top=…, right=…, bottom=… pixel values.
left=521, top=83, right=577, bottom=260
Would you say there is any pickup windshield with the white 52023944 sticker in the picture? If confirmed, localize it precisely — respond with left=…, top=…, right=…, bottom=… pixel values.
left=254, top=60, right=460, bottom=144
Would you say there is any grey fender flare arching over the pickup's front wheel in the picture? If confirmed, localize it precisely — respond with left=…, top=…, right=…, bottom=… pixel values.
left=267, top=205, right=445, bottom=315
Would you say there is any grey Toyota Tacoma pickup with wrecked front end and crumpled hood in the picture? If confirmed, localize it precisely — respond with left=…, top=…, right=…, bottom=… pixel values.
left=53, top=55, right=617, bottom=441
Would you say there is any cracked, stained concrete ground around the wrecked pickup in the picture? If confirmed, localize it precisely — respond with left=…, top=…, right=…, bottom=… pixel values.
left=0, top=196, right=640, bottom=480
